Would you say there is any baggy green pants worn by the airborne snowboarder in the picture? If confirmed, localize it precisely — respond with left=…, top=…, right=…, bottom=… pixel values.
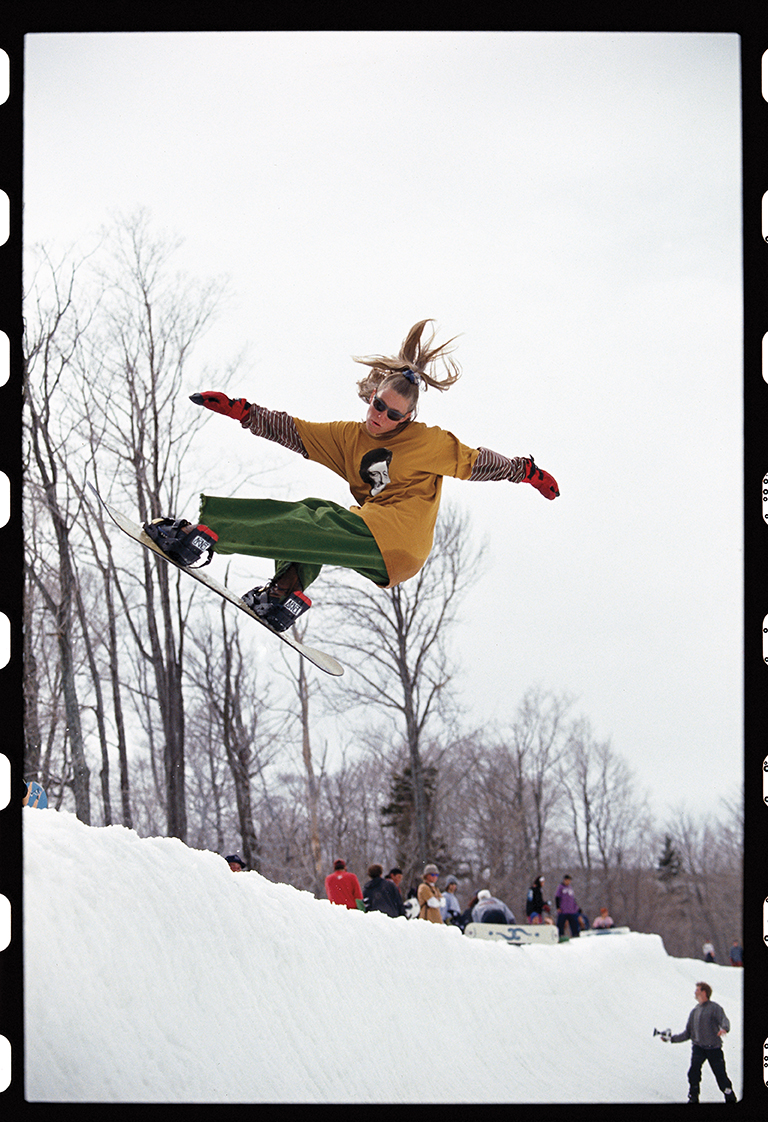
left=200, top=495, right=390, bottom=588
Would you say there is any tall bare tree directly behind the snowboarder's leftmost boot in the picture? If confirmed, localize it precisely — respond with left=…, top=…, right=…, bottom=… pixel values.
left=88, top=212, right=227, bottom=840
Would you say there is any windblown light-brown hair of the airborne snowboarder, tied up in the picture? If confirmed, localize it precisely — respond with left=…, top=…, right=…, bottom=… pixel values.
left=353, top=320, right=461, bottom=416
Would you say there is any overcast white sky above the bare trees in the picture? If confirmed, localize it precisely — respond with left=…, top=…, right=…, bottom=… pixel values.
left=25, top=31, right=743, bottom=812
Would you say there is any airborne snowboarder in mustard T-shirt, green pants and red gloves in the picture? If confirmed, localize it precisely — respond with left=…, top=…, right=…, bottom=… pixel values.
left=145, top=320, right=559, bottom=631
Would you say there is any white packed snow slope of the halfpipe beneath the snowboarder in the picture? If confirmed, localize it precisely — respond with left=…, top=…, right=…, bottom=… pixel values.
left=22, top=809, right=743, bottom=1103
